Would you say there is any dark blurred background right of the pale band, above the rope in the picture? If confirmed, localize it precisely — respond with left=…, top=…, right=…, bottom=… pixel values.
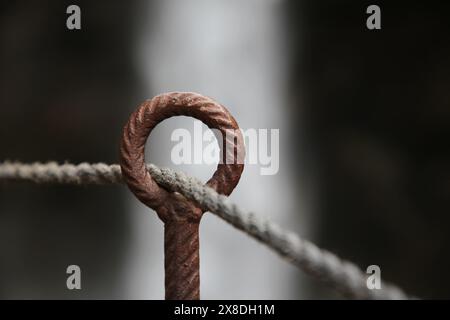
left=289, top=1, right=450, bottom=298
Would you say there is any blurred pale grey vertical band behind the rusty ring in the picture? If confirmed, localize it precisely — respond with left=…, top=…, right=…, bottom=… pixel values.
left=123, top=0, right=307, bottom=299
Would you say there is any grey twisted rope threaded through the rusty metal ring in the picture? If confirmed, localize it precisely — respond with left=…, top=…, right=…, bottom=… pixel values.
left=0, top=162, right=409, bottom=299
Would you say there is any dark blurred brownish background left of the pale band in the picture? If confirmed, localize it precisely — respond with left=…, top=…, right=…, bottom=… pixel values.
left=0, top=1, right=144, bottom=299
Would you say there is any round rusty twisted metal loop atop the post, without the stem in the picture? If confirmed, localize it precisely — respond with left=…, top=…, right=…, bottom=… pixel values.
left=120, top=92, right=245, bottom=222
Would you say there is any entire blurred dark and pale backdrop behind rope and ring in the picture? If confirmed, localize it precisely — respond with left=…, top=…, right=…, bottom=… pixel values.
left=0, top=0, right=450, bottom=299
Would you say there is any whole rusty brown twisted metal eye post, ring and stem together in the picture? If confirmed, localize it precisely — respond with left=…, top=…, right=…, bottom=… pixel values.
left=120, top=92, right=245, bottom=300
